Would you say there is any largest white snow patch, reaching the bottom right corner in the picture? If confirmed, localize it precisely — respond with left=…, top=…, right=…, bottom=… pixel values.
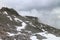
left=36, top=32, right=60, bottom=40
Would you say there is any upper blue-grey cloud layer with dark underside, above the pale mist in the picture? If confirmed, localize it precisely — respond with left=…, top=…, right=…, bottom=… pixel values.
left=1, top=0, right=60, bottom=10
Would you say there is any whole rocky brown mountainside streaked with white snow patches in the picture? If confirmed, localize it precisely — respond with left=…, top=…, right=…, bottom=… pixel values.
left=0, top=7, right=60, bottom=40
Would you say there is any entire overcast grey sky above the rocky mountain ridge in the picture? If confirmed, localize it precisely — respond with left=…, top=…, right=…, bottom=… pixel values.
left=0, top=0, right=60, bottom=28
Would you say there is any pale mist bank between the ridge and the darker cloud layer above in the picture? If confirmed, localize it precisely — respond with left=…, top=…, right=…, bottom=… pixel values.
left=18, top=8, right=60, bottom=29
